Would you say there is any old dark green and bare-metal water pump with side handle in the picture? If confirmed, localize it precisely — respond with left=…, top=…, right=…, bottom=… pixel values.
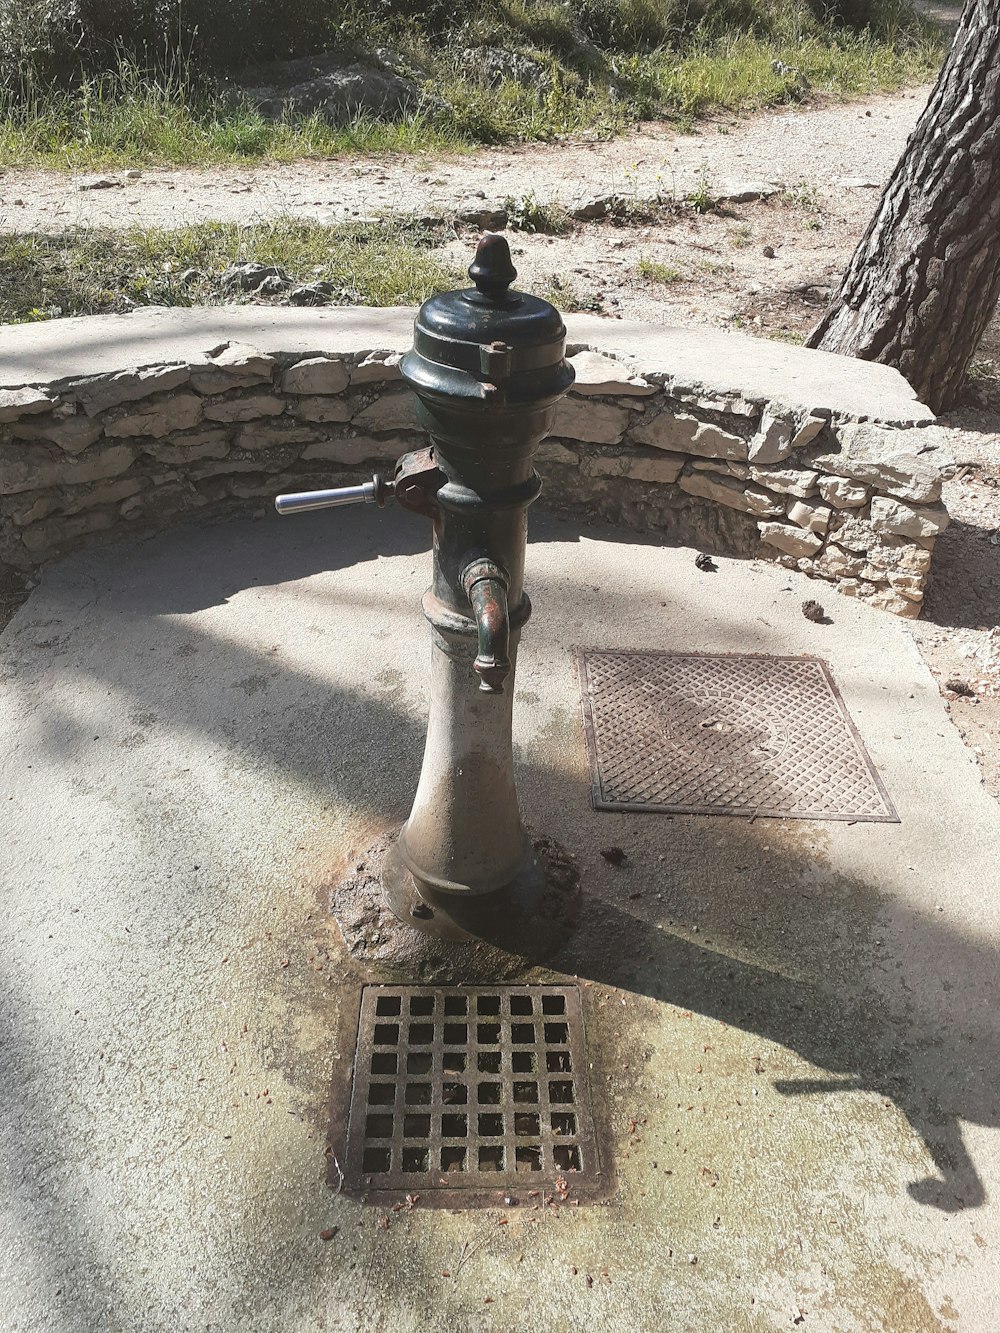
left=276, top=235, right=573, bottom=944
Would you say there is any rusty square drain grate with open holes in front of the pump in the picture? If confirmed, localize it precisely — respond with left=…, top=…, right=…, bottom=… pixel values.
left=344, top=985, right=600, bottom=1206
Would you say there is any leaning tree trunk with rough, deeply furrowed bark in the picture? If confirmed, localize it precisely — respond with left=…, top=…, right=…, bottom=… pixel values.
left=808, top=0, right=1000, bottom=412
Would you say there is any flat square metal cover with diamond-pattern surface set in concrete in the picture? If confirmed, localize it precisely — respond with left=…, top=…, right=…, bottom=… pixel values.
left=576, top=649, right=899, bottom=824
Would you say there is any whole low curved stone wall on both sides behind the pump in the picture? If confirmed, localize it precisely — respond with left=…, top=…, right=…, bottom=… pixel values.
left=0, top=312, right=948, bottom=616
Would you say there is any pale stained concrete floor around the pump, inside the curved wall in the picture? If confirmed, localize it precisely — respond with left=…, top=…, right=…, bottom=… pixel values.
left=0, top=511, right=1000, bottom=1333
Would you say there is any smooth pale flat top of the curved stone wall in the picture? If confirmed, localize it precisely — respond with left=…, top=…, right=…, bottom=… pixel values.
left=0, top=305, right=935, bottom=427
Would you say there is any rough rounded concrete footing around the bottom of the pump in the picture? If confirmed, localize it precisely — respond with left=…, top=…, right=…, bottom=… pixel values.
left=331, top=829, right=580, bottom=982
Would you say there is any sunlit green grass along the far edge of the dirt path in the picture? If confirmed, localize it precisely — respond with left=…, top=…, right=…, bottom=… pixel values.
left=0, top=0, right=945, bottom=171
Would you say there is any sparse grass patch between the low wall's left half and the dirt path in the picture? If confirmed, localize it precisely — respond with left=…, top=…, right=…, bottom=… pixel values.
left=0, top=219, right=461, bottom=323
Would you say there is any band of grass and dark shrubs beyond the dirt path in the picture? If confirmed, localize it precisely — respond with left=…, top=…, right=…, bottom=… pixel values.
left=0, top=0, right=944, bottom=169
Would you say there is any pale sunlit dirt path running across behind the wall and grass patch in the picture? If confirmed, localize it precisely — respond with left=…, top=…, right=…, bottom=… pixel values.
left=0, top=88, right=928, bottom=232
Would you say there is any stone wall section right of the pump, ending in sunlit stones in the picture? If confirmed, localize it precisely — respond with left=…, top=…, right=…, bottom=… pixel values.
left=539, top=351, right=948, bottom=617
